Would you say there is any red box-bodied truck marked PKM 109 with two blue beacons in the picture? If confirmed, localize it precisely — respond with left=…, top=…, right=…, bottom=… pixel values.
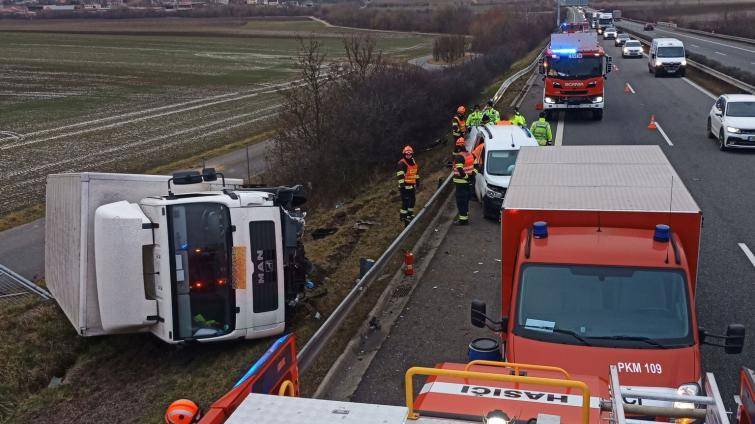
left=472, top=146, right=745, bottom=414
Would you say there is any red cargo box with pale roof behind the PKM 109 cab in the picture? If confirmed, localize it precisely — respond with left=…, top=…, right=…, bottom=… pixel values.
left=501, top=146, right=702, bottom=305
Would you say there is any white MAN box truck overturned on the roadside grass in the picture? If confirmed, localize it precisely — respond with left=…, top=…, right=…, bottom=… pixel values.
left=45, top=169, right=308, bottom=344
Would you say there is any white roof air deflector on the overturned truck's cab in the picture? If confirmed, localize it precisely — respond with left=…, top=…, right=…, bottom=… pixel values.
left=94, top=201, right=158, bottom=332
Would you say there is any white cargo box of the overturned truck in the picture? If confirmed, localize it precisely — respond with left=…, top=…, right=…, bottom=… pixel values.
left=45, top=172, right=242, bottom=336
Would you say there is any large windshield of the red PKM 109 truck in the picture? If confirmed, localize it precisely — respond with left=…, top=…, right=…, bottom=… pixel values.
left=515, top=264, right=693, bottom=348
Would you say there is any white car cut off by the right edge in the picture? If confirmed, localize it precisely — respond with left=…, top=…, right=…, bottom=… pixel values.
left=708, top=94, right=755, bottom=150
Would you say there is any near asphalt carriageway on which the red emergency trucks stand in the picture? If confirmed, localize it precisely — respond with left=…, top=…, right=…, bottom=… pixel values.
left=352, top=41, right=755, bottom=408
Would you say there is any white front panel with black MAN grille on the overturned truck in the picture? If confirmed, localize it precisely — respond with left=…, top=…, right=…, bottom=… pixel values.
left=232, top=206, right=285, bottom=338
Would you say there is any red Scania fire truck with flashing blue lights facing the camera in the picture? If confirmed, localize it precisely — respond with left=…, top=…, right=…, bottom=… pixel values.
left=539, top=32, right=612, bottom=120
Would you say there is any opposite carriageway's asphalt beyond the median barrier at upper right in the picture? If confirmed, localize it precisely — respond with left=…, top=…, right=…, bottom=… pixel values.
left=616, top=20, right=755, bottom=71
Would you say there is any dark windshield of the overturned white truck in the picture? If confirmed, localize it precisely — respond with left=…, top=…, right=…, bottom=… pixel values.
left=168, top=203, right=236, bottom=339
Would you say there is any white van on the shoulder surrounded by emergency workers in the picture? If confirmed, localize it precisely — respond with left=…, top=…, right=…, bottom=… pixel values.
left=467, top=125, right=538, bottom=219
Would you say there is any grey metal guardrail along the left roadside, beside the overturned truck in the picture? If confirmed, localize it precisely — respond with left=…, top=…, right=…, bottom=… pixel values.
left=296, top=50, right=544, bottom=372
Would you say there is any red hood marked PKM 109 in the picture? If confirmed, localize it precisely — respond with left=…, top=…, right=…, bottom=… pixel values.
left=506, top=335, right=700, bottom=389
